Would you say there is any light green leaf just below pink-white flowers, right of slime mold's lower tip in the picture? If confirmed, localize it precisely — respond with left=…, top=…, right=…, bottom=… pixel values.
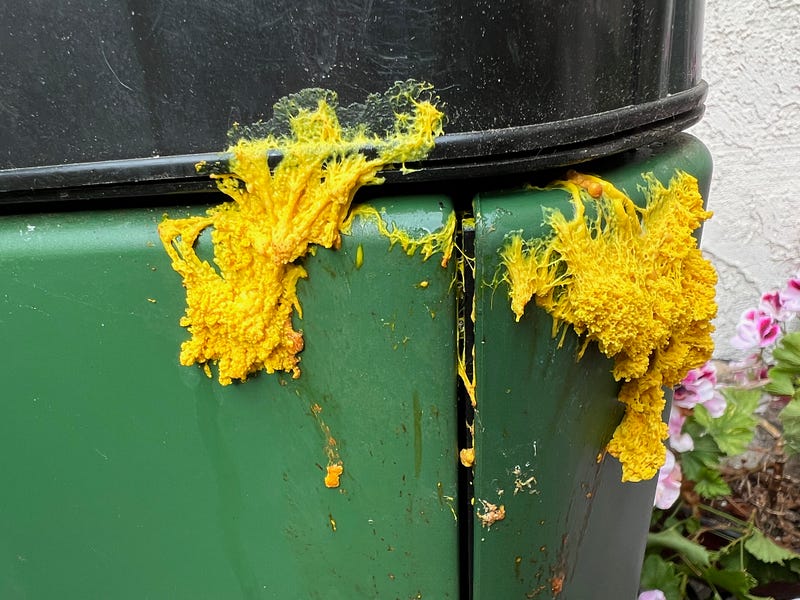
left=694, top=388, right=762, bottom=456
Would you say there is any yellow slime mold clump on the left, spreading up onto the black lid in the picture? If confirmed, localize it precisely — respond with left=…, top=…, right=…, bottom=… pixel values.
left=159, top=81, right=443, bottom=385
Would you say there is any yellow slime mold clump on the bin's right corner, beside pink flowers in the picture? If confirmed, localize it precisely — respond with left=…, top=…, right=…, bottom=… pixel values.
left=502, top=172, right=717, bottom=481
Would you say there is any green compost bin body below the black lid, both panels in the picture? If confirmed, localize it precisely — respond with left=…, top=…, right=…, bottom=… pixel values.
left=0, top=134, right=711, bottom=600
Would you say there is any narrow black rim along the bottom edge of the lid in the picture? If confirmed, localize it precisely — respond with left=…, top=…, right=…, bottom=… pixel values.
left=0, top=80, right=708, bottom=196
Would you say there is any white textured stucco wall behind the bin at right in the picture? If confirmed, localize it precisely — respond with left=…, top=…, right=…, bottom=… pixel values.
left=691, top=0, right=800, bottom=358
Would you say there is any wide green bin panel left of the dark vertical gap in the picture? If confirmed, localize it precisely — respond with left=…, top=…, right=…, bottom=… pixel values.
left=0, top=197, right=459, bottom=600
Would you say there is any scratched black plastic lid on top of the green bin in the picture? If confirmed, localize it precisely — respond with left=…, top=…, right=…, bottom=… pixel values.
left=0, top=0, right=706, bottom=202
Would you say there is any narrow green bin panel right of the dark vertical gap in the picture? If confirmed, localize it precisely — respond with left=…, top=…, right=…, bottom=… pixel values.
left=474, top=135, right=711, bottom=600
